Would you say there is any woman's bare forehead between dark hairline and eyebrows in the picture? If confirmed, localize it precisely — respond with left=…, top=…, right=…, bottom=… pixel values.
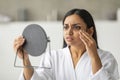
left=64, top=14, right=86, bottom=25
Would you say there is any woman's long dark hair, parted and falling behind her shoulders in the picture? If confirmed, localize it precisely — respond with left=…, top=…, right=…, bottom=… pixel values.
left=63, top=9, right=99, bottom=48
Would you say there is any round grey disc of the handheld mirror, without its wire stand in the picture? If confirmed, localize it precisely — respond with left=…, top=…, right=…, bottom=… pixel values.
left=22, top=24, right=48, bottom=56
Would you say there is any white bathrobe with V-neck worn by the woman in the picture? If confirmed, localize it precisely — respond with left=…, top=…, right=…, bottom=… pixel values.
left=19, top=47, right=119, bottom=80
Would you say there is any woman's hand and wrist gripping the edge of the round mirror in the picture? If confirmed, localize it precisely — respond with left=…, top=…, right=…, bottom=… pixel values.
left=13, top=36, right=28, bottom=59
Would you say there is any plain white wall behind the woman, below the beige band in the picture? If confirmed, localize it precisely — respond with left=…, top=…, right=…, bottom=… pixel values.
left=0, top=21, right=120, bottom=80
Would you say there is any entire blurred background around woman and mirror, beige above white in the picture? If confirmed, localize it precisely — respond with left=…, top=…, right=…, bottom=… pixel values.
left=0, top=0, right=120, bottom=80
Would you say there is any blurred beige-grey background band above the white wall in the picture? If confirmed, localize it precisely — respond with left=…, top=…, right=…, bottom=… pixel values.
left=0, top=0, right=120, bottom=21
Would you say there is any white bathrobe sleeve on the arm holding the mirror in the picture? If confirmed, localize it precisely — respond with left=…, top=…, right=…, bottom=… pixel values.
left=19, top=53, right=53, bottom=80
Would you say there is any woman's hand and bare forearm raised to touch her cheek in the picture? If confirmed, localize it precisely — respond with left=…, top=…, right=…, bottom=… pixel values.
left=80, top=31, right=102, bottom=74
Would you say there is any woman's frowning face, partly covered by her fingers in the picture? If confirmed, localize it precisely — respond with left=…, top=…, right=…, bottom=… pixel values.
left=63, top=14, right=87, bottom=46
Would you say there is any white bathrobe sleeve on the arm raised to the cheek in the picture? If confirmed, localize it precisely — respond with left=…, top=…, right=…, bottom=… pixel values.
left=89, top=53, right=119, bottom=80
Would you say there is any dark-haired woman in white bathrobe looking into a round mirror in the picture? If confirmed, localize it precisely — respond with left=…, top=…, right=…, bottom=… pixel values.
left=14, top=9, right=119, bottom=80
